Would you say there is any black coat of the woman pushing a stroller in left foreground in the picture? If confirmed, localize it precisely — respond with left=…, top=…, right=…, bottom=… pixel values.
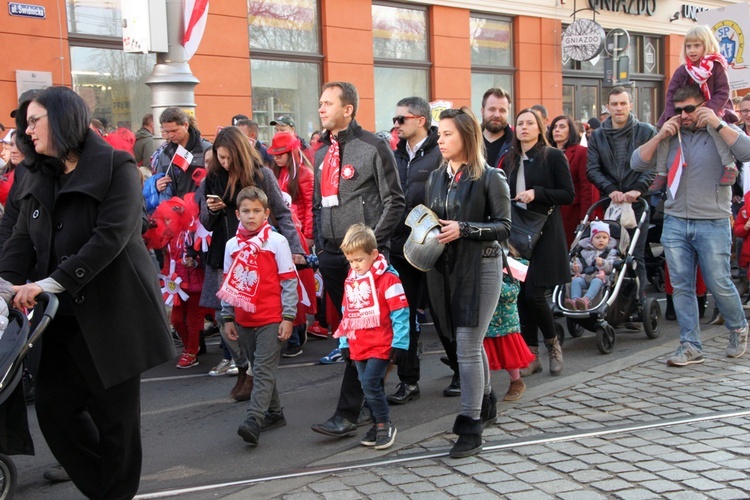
left=0, top=131, right=174, bottom=388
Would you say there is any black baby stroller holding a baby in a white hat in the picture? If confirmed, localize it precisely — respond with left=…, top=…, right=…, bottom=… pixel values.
left=552, top=198, right=661, bottom=354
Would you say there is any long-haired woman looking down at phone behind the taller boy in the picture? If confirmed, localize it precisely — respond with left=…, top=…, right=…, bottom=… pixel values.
left=201, top=127, right=305, bottom=401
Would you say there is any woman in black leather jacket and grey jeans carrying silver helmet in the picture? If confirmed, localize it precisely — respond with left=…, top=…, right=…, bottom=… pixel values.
left=425, top=107, right=510, bottom=458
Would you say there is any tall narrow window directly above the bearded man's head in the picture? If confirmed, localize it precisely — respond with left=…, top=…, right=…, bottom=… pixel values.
left=469, top=15, right=515, bottom=113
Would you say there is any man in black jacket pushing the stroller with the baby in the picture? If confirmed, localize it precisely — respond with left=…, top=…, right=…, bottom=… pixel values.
left=586, top=87, right=656, bottom=300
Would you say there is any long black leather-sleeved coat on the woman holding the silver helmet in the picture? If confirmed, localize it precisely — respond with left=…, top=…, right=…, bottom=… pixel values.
left=425, top=165, right=510, bottom=338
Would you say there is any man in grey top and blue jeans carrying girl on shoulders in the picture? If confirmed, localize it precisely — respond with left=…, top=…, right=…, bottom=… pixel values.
left=631, top=85, right=750, bottom=366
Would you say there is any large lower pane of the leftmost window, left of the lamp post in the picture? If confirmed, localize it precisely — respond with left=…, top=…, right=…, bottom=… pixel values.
left=70, top=47, right=156, bottom=131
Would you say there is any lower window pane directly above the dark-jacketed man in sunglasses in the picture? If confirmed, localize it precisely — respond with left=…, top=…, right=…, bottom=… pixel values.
left=375, top=67, right=429, bottom=131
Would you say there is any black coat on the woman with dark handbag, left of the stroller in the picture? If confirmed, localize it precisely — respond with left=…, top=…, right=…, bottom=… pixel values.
left=503, top=146, right=575, bottom=287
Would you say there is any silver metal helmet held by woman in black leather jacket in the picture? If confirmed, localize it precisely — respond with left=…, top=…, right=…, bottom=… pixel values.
left=404, top=205, right=445, bottom=271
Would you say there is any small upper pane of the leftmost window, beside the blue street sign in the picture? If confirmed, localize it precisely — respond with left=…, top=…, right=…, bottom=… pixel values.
left=65, top=0, right=122, bottom=38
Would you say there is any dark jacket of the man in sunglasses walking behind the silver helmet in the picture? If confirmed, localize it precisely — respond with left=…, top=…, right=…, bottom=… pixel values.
left=391, top=127, right=443, bottom=255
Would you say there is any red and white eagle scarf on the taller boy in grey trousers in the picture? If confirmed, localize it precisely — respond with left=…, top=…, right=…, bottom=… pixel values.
left=216, top=222, right=271, bottom=313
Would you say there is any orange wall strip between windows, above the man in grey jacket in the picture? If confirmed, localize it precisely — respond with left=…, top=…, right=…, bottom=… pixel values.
left=320, top=0, right=375, bottom=130
